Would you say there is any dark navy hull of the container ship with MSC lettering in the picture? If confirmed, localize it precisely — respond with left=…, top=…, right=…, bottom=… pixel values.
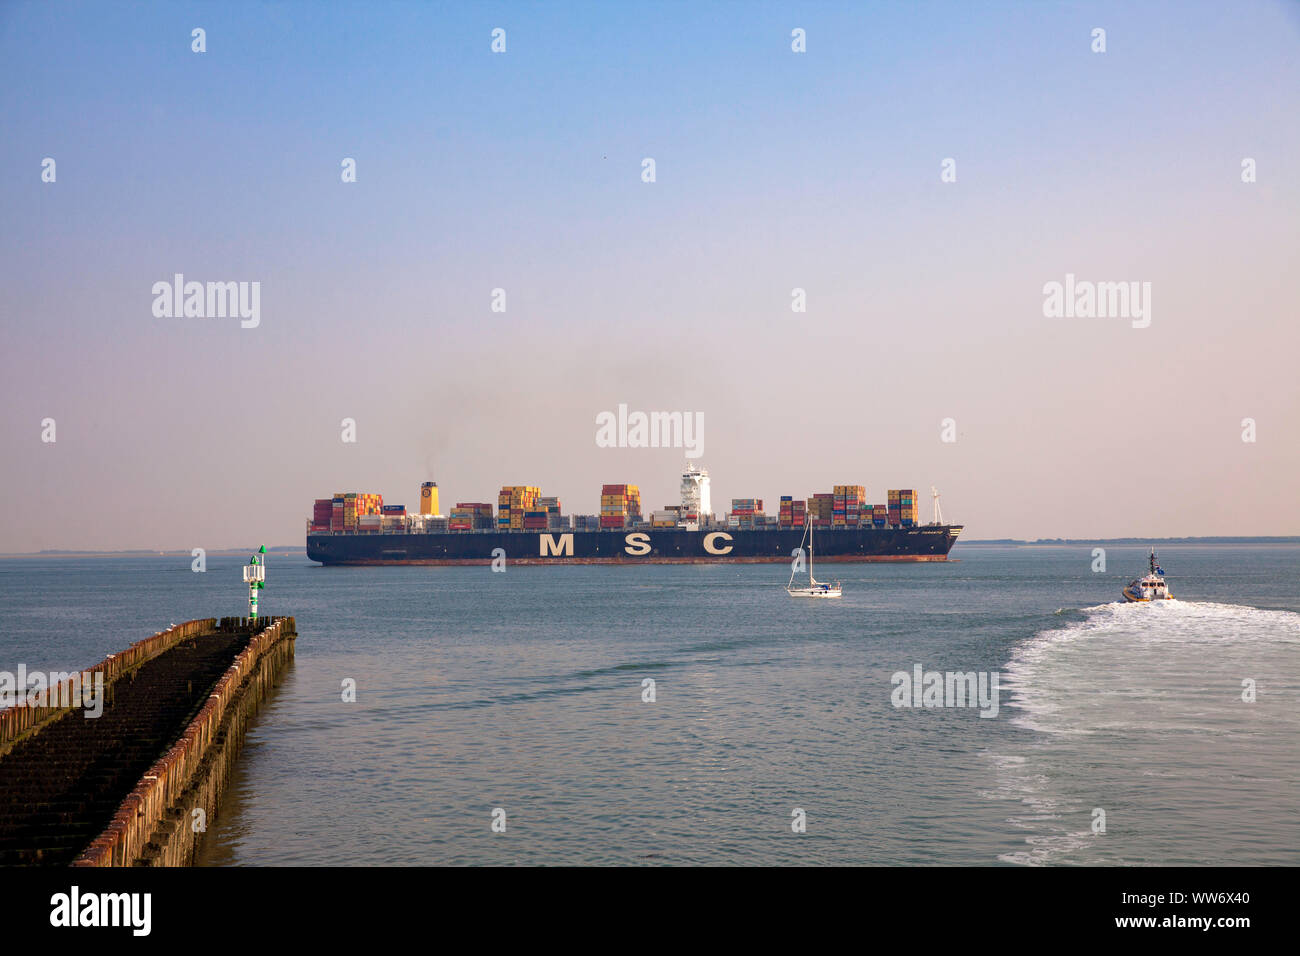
left=307, top=524, right=962, bottom=564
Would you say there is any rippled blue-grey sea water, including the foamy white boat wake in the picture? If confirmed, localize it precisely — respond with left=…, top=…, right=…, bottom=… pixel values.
left=0, top=545, right=1300, bottom=865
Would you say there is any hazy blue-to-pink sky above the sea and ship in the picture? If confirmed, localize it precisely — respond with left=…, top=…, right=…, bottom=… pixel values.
left=0, top=3, right=1300, bottom=551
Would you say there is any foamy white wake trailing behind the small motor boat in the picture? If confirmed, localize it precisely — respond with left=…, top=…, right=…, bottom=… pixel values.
left=987, top=600, right=1300, bottom=865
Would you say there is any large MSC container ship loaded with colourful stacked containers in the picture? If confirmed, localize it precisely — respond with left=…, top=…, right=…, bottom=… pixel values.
left=307, top=464, right=962, bottom=564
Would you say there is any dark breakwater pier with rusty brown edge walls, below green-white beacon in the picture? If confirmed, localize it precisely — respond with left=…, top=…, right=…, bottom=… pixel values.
left=0, top=618, right=298, bottom=866
